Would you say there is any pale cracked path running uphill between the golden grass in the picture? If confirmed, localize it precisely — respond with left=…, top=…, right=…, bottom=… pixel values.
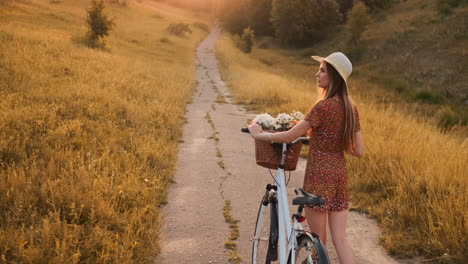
left=156, top=24, right=415, bottom=264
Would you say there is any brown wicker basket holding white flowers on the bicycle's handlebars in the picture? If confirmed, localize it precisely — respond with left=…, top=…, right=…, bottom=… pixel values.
left=255, top=134, right=302, bottom=171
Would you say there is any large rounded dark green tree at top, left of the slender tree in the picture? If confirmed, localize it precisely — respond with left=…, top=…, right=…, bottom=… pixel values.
left=270, top=0, right=343, bottom=47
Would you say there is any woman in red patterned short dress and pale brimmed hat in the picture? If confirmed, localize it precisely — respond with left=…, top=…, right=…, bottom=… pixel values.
left=249, top=52, right=364, bottom=264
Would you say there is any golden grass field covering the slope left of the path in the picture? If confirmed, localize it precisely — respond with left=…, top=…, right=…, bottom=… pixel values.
left=0, top=0, right=206, bottom=263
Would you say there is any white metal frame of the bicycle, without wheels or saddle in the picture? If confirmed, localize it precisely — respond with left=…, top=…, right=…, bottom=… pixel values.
left=254, top=137, right=308, bottom=264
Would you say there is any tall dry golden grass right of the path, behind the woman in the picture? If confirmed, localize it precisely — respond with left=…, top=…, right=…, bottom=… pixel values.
left=217, top=36, right=468, bottom=263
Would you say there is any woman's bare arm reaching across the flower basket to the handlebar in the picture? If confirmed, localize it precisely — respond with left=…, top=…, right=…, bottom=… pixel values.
left=249, top=120, right=310, bottom=143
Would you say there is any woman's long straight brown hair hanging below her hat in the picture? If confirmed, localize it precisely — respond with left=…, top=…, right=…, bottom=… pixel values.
left=322, top=62, right=356, bottom=147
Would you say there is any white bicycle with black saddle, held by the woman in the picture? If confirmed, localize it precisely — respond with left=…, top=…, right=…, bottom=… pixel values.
left=241, top=128, right=330, bottom=264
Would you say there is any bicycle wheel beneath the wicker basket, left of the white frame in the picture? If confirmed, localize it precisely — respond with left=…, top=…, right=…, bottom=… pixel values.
left=252, top=198, right=279, bottom=264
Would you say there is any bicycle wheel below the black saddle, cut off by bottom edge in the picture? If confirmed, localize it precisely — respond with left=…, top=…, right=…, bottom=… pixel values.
left=296, top=233, right=330, bottom=264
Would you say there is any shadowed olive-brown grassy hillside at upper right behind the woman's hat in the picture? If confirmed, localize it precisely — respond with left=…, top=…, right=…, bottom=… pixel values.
left=252, top=0, right=468, bottom=129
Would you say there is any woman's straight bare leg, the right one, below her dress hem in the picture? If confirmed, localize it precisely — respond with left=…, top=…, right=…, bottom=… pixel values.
left=328, top=210, right=354, bottom=264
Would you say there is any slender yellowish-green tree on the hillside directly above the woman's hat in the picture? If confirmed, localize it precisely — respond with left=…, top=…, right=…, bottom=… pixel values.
left=346, top=1, right=370, bottom=44
